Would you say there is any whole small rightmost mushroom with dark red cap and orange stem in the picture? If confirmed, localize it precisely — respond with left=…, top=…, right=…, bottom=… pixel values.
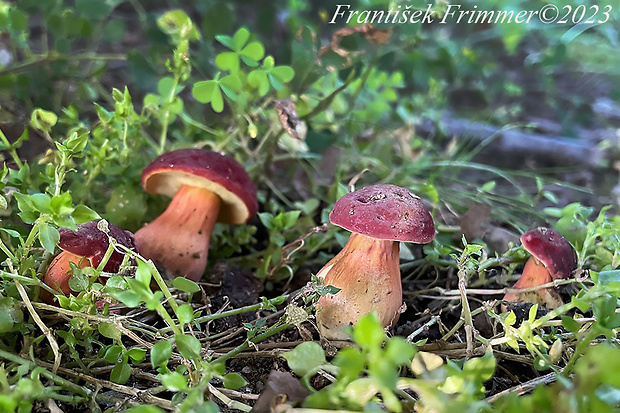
left=502, top=227, right=577, bottom=311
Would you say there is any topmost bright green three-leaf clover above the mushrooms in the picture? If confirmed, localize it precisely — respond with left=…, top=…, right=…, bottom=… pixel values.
left=215, top=27, right=265, bottom=75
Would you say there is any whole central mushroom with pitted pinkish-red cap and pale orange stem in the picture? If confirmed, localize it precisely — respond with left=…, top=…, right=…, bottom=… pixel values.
left=316, top=185, right=435, bottom=340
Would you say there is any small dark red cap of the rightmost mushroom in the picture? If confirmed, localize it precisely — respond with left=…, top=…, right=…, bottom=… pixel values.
left=521, top=227, right=577, bottom=280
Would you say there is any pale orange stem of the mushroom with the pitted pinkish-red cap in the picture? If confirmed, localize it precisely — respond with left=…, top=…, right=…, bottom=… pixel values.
left=316, top=233, right=403, bottom=340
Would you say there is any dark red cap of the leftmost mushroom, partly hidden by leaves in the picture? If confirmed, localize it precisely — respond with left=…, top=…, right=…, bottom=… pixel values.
left=58, top=220, right=136, bottom=272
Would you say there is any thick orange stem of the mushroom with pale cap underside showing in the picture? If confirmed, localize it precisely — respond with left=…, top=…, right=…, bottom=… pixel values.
left=135, top=185, right=221, bottom=281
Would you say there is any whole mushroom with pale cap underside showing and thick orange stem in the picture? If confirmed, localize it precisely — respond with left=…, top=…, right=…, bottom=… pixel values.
left=136, top=149, right=258, bottom=281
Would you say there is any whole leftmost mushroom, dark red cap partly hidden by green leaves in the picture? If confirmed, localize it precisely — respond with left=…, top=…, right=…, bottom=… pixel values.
left=42, top=220, right=135, bottom=303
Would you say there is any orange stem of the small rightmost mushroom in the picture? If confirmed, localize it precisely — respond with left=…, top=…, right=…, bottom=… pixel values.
left=502, top=257, right=563, bottom=311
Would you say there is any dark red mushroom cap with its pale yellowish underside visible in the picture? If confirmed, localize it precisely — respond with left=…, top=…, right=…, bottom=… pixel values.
left=142, top=149, right=258, bottom=224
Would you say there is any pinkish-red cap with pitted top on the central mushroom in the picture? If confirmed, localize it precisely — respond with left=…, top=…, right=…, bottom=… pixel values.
left=329, top=185, right=435, bottom=244
